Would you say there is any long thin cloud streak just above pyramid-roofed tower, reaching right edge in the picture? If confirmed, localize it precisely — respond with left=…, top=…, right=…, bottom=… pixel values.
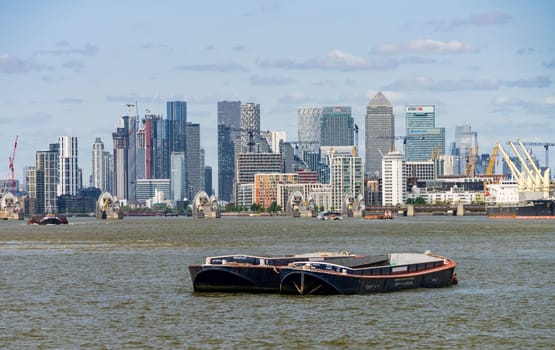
left=384, top=76, right=551, bottom=91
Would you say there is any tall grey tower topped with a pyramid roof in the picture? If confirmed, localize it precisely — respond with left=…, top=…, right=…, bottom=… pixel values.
left=365, top=92, right=395, bottom=177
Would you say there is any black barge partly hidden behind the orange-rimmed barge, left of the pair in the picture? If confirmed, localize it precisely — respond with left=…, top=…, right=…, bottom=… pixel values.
left=189, top=252, right=387, bottom=293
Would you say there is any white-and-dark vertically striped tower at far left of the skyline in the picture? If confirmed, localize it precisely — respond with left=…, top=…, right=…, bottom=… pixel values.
left=57, top=136, right=80, bottom=196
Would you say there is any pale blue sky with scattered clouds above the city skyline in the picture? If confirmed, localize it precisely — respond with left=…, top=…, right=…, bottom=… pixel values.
left=0, top=0, right=555, bottom=191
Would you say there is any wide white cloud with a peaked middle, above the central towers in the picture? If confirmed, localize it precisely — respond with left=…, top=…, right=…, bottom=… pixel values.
left=257, top=50, right=398, bottom=71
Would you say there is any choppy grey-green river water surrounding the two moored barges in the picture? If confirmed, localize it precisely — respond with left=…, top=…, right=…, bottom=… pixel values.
left=0, top=216, right=555, bottom=349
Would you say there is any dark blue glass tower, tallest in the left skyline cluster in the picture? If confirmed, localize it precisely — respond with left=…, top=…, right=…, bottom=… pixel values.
left=166, top=101, right=187, bottom=154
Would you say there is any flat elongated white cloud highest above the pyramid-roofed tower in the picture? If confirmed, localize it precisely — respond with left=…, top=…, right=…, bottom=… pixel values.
left=370, top=39, right=479, bottom=55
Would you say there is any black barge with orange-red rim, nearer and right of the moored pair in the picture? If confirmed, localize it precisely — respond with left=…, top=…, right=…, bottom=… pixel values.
left=280, top=252, right=457, bottom=295
